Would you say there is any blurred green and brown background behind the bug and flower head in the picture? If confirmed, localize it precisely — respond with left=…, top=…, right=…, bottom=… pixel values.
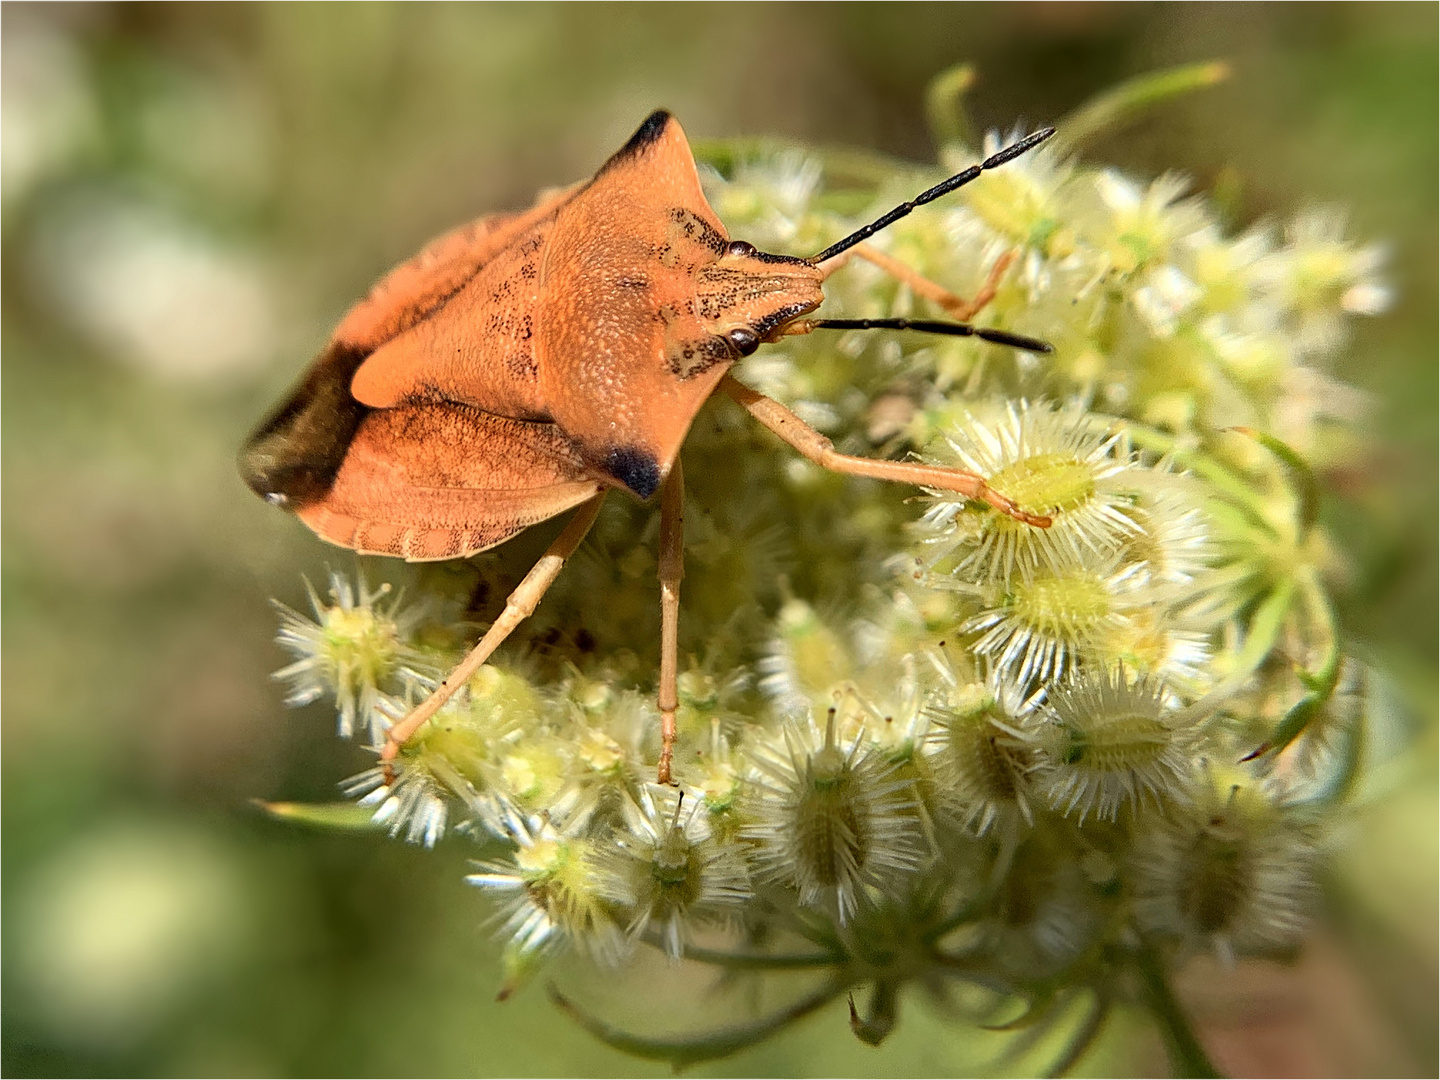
left=0, top=3, right=1437, bottom=1076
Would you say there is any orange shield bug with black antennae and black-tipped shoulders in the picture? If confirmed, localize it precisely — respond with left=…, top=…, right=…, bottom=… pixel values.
left=240, top=111, right=1054, bottom=783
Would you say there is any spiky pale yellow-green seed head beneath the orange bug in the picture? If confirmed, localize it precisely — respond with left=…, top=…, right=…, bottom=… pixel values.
left=259, top=66, right=1391, bottom=1068
